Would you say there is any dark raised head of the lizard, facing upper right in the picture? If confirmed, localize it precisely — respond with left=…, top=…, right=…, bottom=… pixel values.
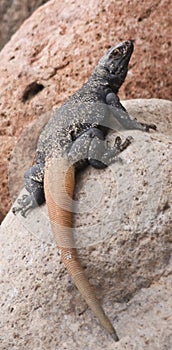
left=96, top=40, right=134, bottom=92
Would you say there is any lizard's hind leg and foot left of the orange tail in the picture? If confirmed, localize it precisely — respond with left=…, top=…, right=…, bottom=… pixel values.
left=12, top=163, right=45, bottom=217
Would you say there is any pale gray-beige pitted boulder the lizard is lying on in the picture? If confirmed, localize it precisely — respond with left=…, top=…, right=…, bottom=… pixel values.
left=0, top=100, right=172, bottom=350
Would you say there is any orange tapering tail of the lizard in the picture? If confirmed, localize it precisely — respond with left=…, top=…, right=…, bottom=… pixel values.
left=44, top=159, right=119, bottom=341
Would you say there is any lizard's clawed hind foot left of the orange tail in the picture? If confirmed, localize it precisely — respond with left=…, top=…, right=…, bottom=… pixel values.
left=12, top=194, right=38, bottom=217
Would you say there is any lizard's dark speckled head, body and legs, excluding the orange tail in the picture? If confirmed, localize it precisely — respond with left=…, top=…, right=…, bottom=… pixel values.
left=13, top=40, right=155, bottom=216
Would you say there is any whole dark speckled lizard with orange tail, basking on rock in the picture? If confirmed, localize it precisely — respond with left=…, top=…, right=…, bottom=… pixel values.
left=13, top=40, right=156, bottom=341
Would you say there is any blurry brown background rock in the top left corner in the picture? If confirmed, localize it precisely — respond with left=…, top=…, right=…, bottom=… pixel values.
left=0, top=0, right=49, bottom=49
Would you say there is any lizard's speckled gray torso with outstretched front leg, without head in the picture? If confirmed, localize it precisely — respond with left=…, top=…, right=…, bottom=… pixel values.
left=37, top=66, right=149, bottom=161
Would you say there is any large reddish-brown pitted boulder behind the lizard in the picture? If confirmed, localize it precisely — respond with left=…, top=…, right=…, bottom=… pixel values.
left=0, top=0, right=171, bottom=217
